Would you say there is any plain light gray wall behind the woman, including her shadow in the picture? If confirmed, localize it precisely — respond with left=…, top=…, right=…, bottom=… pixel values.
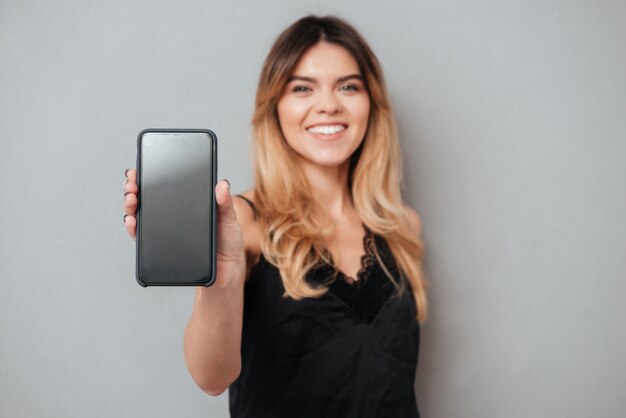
left=0, top=0, right=626, bottom=418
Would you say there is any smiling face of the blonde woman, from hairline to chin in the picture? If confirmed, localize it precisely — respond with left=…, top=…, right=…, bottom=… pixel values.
left=278, top=42, right=370, bottom=166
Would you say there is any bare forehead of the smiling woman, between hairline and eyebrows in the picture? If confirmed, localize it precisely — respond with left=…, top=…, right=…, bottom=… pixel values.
left=292, top=42, right=361, bottom=78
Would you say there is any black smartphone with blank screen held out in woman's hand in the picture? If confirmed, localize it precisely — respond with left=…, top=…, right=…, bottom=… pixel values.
left=136, top=129, right=217, bottom=287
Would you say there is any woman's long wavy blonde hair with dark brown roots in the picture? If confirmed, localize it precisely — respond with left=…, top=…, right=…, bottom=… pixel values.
left=252, top=16, right=426, bottom=322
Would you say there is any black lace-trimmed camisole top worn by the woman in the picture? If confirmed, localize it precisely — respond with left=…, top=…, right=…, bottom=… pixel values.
left=229, top=197, right=419, bottom=418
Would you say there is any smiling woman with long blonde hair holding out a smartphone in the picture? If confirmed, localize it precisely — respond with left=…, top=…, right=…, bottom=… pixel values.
left=124, top=16, right=426, bottom=418
